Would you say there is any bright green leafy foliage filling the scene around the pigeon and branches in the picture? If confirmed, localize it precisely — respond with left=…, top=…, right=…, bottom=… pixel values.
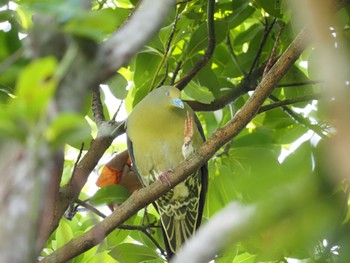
left=0, top=0, right=350, bottom=263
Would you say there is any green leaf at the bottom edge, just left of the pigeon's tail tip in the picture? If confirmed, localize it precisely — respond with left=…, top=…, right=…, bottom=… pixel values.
left=109, top=243, right=159, bottom=263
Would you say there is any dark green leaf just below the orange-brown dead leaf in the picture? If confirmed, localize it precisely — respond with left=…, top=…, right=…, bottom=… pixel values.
left=90, top=184, right=130, bottom=205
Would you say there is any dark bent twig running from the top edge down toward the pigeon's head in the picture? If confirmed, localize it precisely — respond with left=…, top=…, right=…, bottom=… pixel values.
left=176, top=0, right=216, bottom=90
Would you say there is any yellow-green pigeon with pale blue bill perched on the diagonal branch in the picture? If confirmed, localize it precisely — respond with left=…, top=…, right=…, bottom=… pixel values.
left=126, top=86, right=208, bottom=259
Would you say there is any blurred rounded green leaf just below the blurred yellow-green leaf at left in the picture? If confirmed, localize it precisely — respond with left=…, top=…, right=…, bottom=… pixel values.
left=46, top=113, right=92, bottom=149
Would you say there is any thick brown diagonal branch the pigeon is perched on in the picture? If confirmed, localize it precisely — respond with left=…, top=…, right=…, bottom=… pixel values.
left=41, top=25, right=307, bottom=262
